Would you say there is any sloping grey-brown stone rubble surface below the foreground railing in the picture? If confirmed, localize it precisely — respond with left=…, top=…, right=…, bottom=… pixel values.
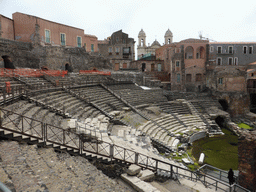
left=0, top=141, right=135, bottom=192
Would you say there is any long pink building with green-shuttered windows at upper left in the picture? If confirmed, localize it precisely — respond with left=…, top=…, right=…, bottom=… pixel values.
left=1, top=12, right=98, bottom=52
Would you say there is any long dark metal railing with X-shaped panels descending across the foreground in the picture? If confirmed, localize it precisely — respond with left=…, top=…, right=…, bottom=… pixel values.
left=0, top=109, right=252, bottom=192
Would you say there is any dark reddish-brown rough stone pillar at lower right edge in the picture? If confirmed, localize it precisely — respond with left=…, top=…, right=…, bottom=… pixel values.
left=238, top=131, right=256, bottom=191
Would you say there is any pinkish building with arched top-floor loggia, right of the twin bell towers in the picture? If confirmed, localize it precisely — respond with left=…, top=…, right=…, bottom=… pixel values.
left=156, top=39, right=209, bottom=91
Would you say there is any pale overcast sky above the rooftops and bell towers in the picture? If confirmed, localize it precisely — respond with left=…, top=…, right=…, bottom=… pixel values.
left=0, top=0, right=256, bottom=47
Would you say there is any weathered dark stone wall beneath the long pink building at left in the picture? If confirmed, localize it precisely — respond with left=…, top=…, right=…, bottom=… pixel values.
left=0, top=38, right=112, bottom=72
